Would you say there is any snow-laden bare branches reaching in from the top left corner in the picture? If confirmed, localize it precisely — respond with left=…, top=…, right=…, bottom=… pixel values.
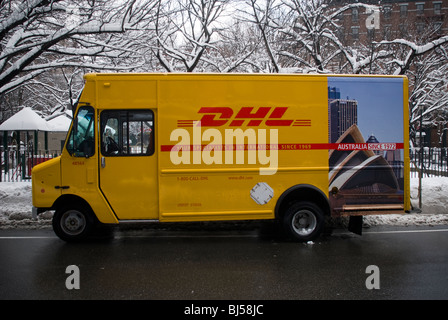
left=0, top=0, right=155, bottom=94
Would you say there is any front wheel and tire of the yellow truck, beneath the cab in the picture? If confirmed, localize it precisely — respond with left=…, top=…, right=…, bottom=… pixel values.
left=52, top=205, right=95, bottom=242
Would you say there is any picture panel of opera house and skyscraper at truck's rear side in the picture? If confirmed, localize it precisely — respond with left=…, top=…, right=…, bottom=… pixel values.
left=328, top=77, right=407, bottom=216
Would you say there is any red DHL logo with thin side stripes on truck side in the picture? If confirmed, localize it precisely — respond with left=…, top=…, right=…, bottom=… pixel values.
left=177, top=107, right=311, bottom=127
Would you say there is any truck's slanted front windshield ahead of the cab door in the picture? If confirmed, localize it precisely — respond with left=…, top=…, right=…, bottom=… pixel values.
left=67, top=106, right=95, bottom=158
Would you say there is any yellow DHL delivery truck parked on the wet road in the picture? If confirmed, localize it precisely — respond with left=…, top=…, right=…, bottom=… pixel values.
left=32, top=74, right=410, bottom=241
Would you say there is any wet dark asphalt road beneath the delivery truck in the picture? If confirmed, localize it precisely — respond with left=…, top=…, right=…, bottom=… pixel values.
left=0, top=222, right=448, bottom=300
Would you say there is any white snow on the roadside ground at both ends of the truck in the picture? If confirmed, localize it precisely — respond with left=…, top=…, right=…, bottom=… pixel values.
left=0, top=177, right=448, bottom=229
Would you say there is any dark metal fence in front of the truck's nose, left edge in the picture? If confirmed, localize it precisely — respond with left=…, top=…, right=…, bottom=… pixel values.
left=0, top=145, right=60, bottom=182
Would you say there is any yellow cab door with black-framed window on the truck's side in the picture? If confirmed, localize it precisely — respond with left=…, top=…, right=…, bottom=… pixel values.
left=99, top=109, right=159, bottom=220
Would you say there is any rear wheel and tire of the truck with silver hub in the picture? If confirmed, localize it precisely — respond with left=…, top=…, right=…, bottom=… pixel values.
left=283, top=201, right=325, bottom=242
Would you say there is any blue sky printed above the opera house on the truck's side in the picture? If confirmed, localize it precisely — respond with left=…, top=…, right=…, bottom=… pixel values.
left=328, top=77, right=404, bottom=143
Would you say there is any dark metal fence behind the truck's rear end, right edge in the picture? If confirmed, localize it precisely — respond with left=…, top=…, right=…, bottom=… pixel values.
left=409, top=147, right=448, bottom=178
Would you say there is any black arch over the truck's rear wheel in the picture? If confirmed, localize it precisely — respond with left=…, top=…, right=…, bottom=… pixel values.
left=275, top=184, right=331, bottom=218
